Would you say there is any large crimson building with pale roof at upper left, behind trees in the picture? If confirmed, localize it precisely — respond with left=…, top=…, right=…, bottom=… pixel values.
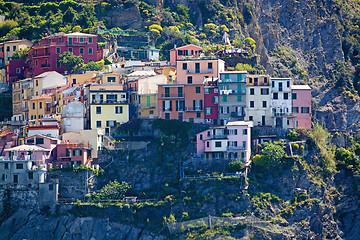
left=27, top=33, right=101, bottom=76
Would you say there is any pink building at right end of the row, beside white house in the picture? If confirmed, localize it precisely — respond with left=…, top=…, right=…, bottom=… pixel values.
left=291, top=85, right=311, bottom=129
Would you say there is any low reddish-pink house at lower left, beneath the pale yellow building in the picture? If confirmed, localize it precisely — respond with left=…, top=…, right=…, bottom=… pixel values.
left=53, top=143, right=91, bottom=168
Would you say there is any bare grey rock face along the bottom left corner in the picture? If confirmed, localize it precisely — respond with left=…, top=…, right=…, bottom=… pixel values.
left=0, top=209, right=164, bottom=240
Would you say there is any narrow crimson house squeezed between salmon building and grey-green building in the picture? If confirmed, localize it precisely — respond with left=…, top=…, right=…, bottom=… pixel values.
left=204, top=78, right=219, bottom=125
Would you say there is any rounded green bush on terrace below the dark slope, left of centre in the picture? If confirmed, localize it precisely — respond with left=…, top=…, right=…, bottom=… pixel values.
left=97, top=180, right=131, bottom=199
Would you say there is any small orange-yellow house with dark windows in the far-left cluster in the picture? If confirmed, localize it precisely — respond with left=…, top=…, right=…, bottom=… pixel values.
left=29, top=94, right=51, bottom=122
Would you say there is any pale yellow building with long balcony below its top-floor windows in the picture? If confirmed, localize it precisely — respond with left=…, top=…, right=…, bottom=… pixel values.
left=90, top=85, right=129, bottom=134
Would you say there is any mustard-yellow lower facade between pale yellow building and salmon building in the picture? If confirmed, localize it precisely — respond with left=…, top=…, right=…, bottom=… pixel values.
left=138, top=94, right=158, bottom=118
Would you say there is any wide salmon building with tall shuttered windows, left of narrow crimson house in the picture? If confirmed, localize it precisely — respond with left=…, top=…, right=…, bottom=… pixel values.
left=158, top=84, right=204, bottom=123
